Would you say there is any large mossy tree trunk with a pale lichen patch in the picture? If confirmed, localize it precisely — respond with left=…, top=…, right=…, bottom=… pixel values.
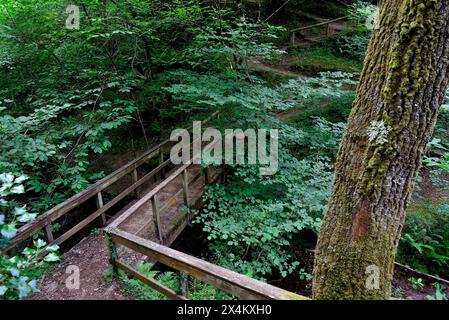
left=313, top=0, right=449, bottom=299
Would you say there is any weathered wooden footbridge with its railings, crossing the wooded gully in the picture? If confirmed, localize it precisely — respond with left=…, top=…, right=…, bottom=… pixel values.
left=4, top=113, right=307, bottom=300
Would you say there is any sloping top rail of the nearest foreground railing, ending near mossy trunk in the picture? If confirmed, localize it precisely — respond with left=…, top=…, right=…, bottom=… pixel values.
left=109, top=229, right=309, bottom=300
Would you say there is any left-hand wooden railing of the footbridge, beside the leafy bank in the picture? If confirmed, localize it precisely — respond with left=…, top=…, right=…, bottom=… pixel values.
left=3, top=111, right=219, bottom=252
